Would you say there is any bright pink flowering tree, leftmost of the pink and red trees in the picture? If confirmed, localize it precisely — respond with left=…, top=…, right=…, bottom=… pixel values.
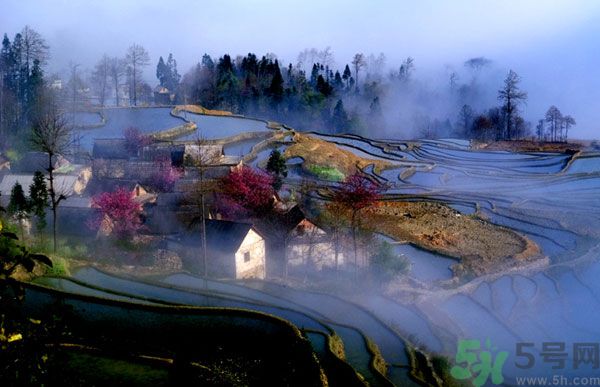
left=90, top=187, right=143, bottom=239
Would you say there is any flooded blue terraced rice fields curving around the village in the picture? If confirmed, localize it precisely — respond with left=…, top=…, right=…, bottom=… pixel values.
left=47, top=108, right=600, bottom=385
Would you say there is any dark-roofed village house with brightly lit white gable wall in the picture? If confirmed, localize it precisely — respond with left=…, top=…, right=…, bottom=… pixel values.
left=167, top=219, right=266, bottom=279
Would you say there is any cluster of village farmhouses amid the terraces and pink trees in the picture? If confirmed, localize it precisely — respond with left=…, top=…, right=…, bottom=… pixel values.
left=0, top=138, right=344, bottom=279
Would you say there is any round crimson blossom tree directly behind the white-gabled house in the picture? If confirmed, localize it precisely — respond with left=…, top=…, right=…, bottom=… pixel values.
left=219, top=165, right=275, bottom=218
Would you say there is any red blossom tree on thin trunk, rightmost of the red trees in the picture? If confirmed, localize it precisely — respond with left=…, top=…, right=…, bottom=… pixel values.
left=333, top=173, right=385, bottom=269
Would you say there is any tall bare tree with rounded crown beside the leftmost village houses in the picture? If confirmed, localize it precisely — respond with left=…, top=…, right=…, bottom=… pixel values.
left=31, top=105, right=73, bottom=252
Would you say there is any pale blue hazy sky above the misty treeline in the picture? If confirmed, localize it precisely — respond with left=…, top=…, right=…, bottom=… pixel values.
left=0, top=0, right=600, bottom=137
